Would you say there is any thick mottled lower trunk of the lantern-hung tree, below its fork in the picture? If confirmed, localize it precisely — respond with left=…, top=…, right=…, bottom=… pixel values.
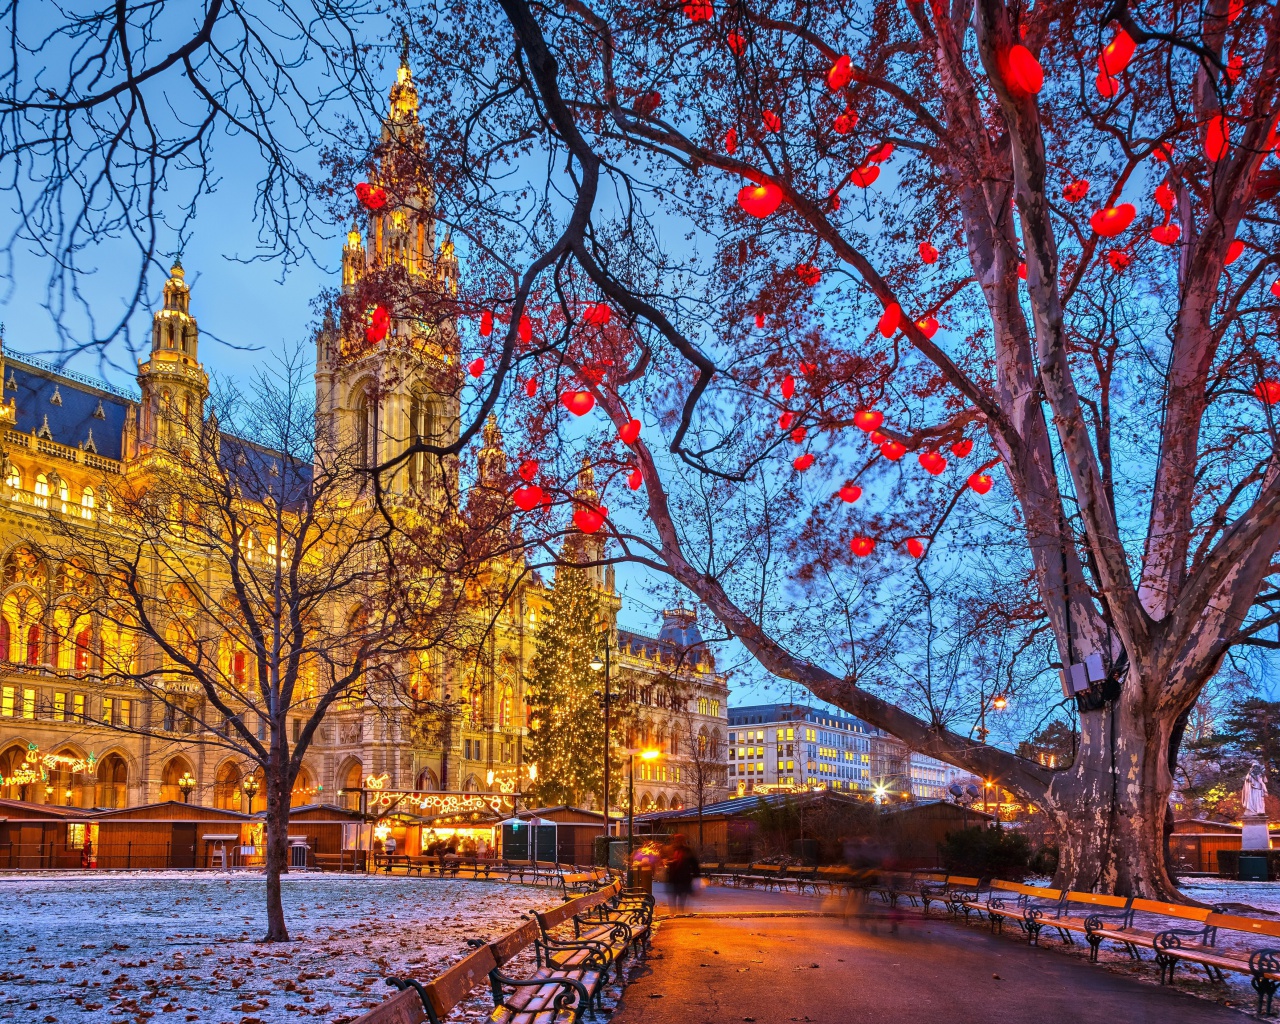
left=1043, top=686, right=1183, bottom=902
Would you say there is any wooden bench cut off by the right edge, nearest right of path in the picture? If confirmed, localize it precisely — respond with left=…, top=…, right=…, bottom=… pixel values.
left=1152, top=911, right=1280, bottom=1016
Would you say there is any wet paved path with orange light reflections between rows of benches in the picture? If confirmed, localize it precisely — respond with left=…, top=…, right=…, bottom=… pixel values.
left=611, top=888, right=1247, bottom=1024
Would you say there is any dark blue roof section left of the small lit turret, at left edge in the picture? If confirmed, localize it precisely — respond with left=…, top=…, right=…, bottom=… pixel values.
left=4, top=351, right=134, bottom=461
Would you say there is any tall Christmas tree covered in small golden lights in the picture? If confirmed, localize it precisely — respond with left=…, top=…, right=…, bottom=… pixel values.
left=525, top=566, right=620, bottom=806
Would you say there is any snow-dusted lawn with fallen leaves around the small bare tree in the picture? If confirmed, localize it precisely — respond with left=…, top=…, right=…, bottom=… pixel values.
left=0, top=872, right=576, bottom=1024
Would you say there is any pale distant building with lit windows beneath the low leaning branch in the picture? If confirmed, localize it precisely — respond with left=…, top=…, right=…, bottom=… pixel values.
left=728, top=703, right=955, bottom=800
